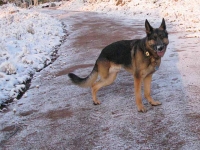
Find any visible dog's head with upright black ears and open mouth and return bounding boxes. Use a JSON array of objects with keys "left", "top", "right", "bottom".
[{"left": 145, "top": 18, "right": 169, "bottom": 57}]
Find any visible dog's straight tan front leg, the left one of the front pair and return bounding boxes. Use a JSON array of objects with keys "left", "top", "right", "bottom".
[{"left": 134, "top": 76, "right": 146, "bottom": 112}]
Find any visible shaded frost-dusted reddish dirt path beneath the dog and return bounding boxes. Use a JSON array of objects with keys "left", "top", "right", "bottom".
[{"left": 0, "top": 10, "right": 200, "bottom": 150}]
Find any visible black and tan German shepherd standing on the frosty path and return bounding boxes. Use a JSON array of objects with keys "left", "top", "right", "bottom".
[{"left": 68, "top": 18, "right": 169, "bottom": 112}]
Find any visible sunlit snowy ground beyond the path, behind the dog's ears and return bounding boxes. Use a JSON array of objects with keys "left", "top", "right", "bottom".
[{"left": 60, "top": 0, "right": 200, "bottom": 37}]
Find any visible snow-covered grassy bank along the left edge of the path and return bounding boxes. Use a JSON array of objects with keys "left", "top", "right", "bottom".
[{"left": 0, "top": 4, "right": 64, "bottom": 104}]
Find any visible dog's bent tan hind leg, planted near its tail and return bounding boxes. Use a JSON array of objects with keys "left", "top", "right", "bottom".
[{"left": 92, "top": 72, "right": 117, "bottom": 105}]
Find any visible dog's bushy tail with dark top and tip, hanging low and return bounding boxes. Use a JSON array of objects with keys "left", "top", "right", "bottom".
[{"left": 68, "top": 64, "right": 98, "bottom": 87}]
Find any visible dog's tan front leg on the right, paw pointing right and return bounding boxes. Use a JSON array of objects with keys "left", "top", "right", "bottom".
[{"left": 144, "top": 74, "right": 161, "bottom": 106}]
